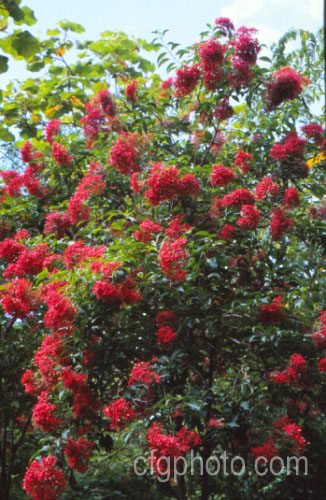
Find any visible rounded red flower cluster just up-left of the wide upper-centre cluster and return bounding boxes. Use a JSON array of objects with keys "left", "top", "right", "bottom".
[{"left": 109, "top": 132, "right": 141, "bottom": 175}]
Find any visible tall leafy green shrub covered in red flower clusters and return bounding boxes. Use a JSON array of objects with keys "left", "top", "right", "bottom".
[{"left": 0, "top": 6, "right": 326, "bottom": 500}]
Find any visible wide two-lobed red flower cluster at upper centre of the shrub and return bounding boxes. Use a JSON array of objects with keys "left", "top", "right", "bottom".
[{"left": 145, "top": 162, "right": 200, "bottom": 206}]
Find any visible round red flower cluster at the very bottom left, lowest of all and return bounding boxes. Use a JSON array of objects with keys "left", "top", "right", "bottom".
[{"left": 23, "top": 455, "right": 67, "bottom": 500}]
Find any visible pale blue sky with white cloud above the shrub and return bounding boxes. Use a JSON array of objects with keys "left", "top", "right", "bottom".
[{"left": 0, "top": 0, "right": 323, "bottom": 87}]
